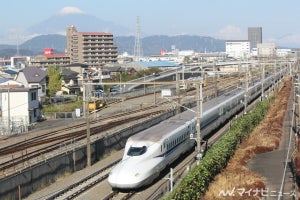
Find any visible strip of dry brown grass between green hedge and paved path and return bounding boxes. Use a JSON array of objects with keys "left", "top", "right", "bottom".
[{"left": 204, "top": 79, "right": 291, "bottom": 200}]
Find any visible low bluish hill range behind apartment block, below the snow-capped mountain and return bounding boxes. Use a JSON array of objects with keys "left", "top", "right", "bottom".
[{"left": 0, "top": 34, "right": 225, "bottom": 58}]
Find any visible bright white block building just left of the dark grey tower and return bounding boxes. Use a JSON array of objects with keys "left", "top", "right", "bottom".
[{"left": 226, "top": 40, "right": 250, "bottom": 59}]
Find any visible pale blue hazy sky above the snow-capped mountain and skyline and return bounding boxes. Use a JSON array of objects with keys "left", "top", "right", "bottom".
[{"left": 0, "top": 0, "right": 300, "bottom": 47}]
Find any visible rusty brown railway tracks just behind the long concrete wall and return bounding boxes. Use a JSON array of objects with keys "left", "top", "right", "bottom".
[{"left": 0, "top": 102, "right": 171, "bottom": 176}]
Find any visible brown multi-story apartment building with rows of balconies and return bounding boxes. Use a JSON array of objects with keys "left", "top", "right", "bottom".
[{"left": 66, "top": 26, "right": 118, "bottom": 66}]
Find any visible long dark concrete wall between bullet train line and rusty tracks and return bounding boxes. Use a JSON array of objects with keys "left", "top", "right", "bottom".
[{"left": 0, "top": 112, "right": 175, "bottom": 200}]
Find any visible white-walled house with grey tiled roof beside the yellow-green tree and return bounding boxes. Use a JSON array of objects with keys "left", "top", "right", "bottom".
[{"left": 15, "top": 67, "right": 47, "bottom": 100}]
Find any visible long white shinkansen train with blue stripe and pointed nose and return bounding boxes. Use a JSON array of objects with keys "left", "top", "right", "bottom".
[{"left": 108, "top": 70, "right": 281, "bottom": 189}]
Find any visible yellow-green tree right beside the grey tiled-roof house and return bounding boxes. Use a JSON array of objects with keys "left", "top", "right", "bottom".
[{"left": 47, "top": 66, "right": 62, "bottom": 102}]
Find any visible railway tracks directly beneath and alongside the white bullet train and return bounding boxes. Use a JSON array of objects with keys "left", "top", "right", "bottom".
[{"left": 55, "top": 115, "right": 230, "bottom": 200}]
